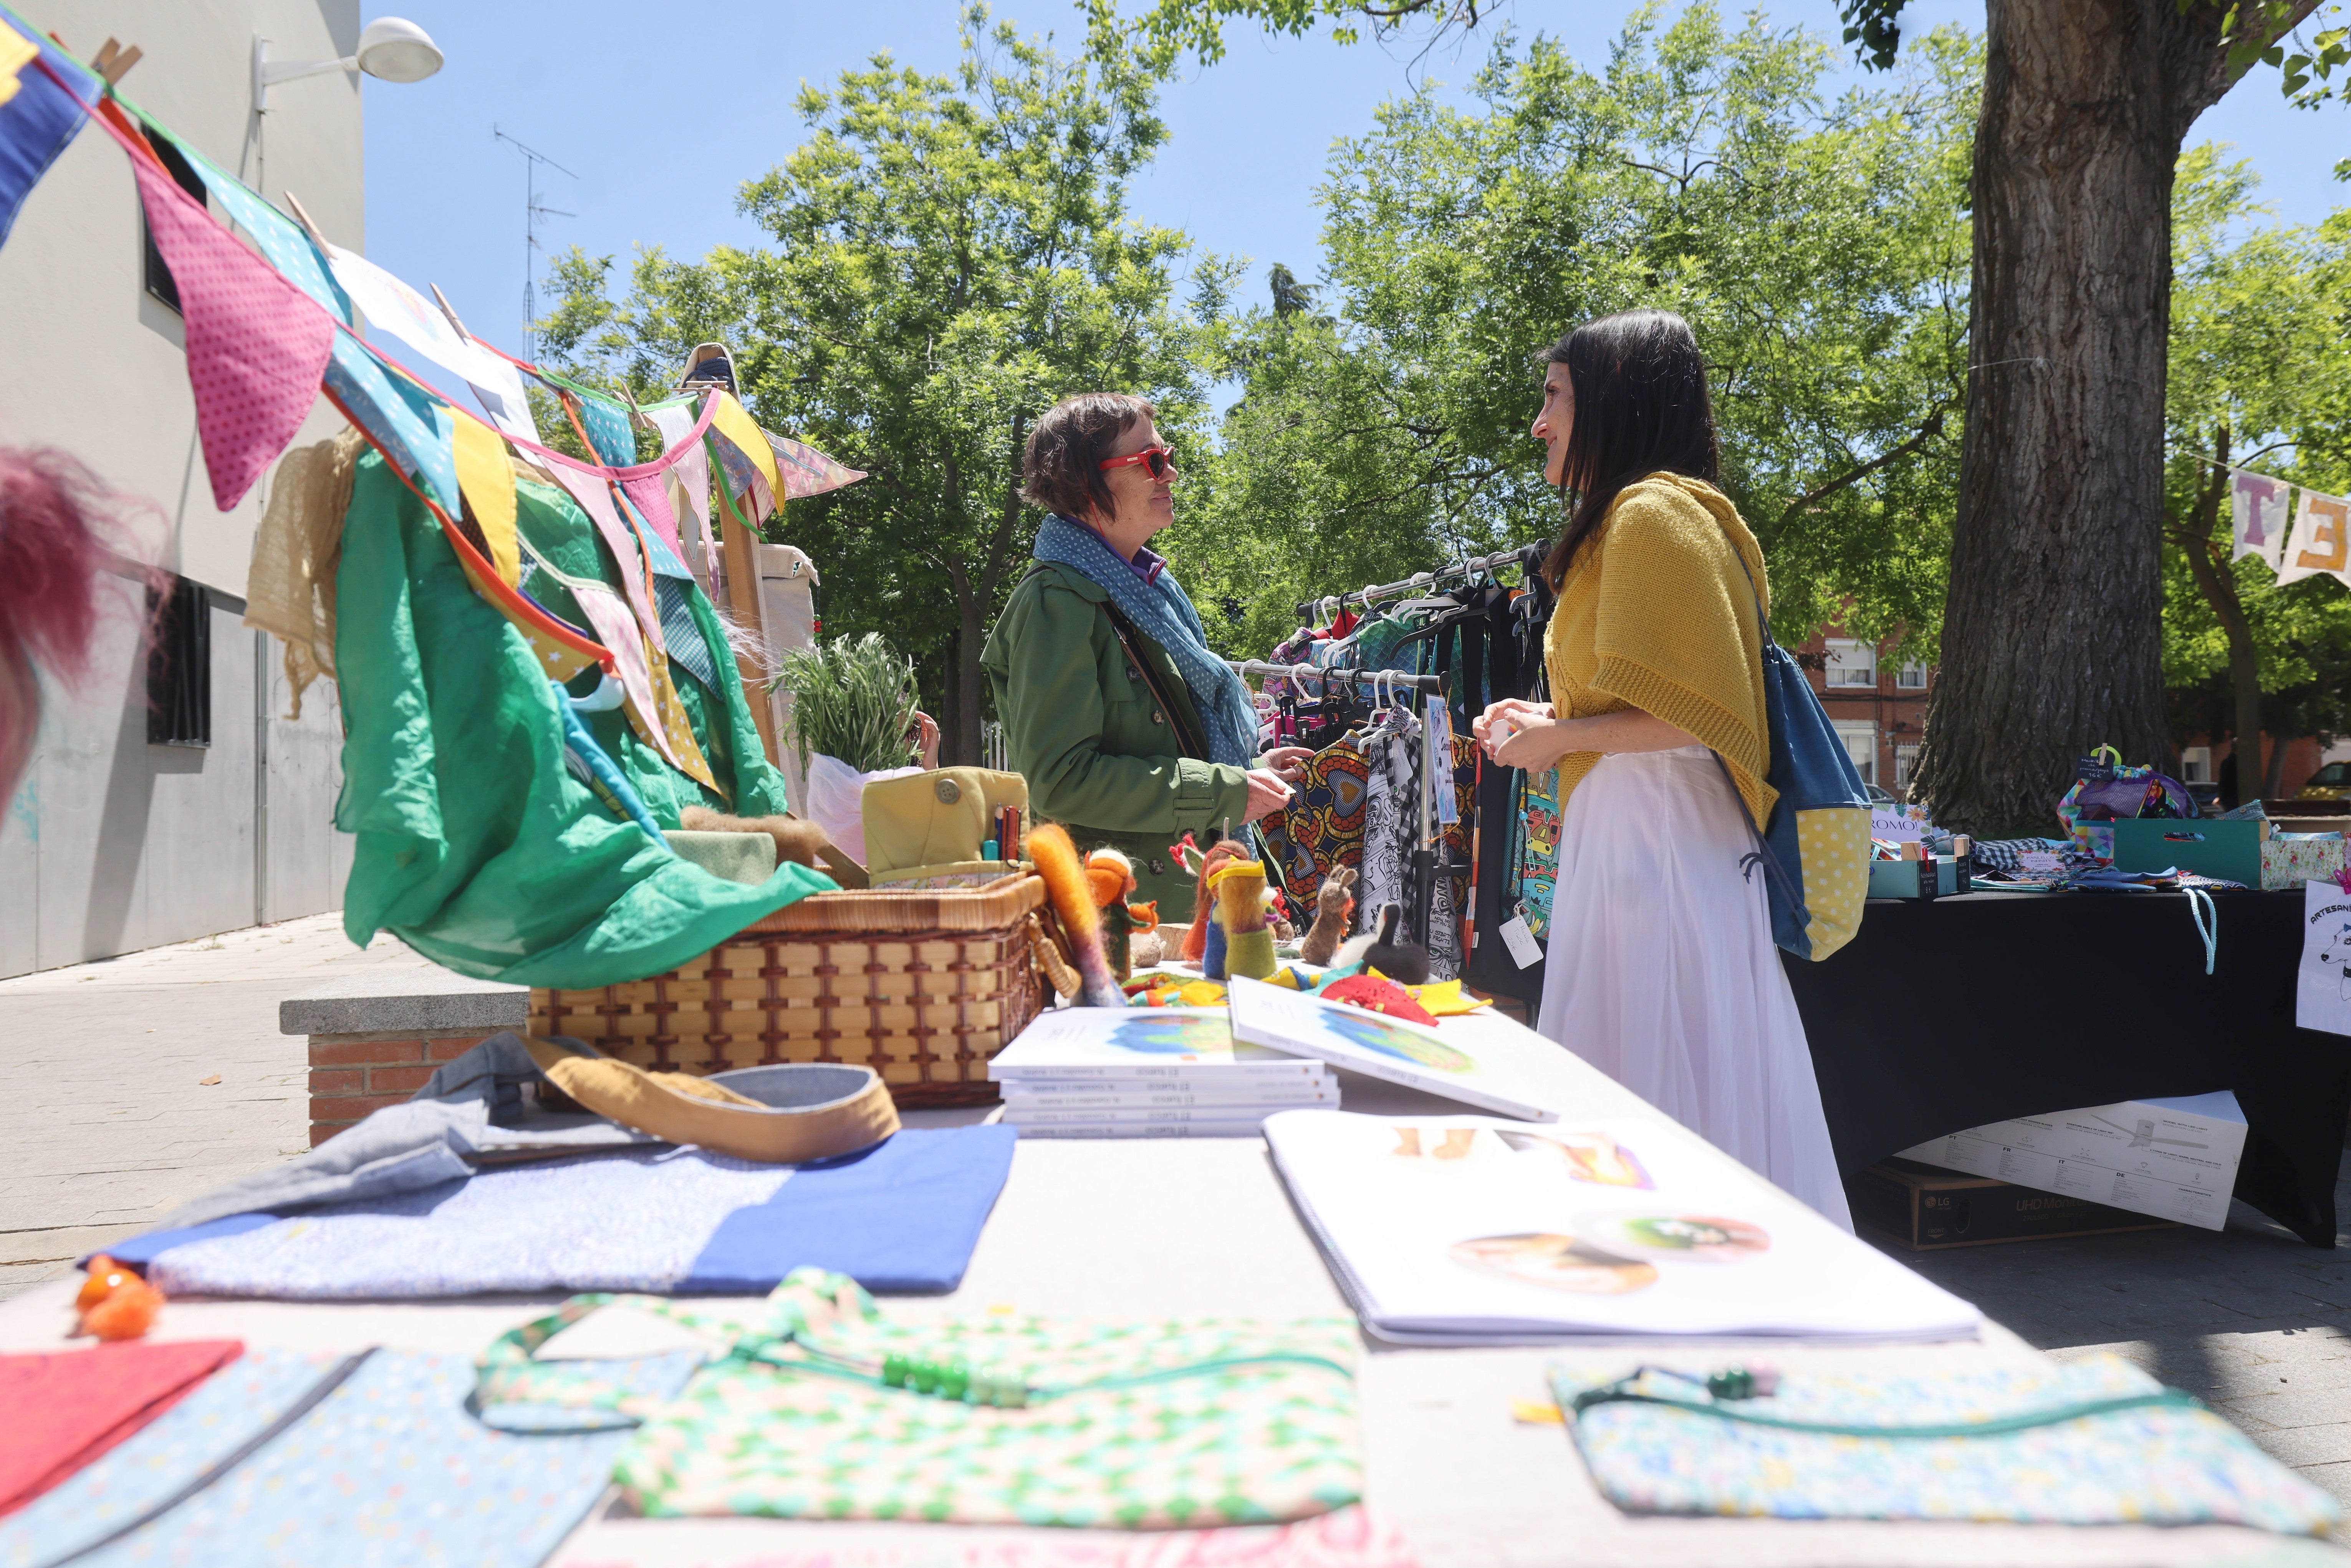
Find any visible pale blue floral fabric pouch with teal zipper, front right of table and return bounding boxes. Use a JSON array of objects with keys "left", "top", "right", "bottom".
[{"left": 1552, "top": 1354, "right": 2342, "bottom": 1535}]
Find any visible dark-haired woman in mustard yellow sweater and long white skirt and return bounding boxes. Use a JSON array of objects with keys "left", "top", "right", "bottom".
[{"left": 1474, "top": 310, "right": 1853, "bottom": 1230}]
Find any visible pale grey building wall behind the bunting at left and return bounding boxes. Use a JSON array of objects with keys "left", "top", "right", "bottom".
[{"left": 0, "top": 0, "right": 364, "bottom": 975}]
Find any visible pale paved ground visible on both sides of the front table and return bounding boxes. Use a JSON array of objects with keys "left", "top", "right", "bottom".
[{"left": 0, "top": 914, "right": 2351, "bottom": 1545}]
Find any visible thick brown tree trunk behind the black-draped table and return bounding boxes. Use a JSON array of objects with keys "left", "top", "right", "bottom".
[{"left": 1921, "top": 0, "right": 2227, "bottom": 837}]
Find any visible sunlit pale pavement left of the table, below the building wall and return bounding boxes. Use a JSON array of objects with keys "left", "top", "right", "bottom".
[{"left": 0, "top": 914, "right": 425, "bottom": 1300}]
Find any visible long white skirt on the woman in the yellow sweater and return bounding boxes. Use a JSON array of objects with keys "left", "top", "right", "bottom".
[{"left": 1538, "top": 745, "right": 1853, "bottom": 1230}]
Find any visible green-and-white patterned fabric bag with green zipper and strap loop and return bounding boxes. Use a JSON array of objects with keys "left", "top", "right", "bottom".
[{"left": 477, "top": 1270, "right": 1364, "bottom": 1528}]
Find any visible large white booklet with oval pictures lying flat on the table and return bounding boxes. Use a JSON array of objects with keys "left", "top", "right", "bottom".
[{"left": 1265, "top": 1109, "right": 1980, "bottom": 1344}]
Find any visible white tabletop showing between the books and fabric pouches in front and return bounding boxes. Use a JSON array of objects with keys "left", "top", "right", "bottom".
[{"left": 0, "top": 1015, "right": 2351, "bottom": 1568}]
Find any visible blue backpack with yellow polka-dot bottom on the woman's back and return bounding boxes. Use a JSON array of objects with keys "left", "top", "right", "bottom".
[{"left": 1714, "top": 529, "right": 1869, "bottom": 959}]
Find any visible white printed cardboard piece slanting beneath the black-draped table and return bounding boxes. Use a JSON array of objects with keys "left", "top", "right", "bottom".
[{"left": 1902, "top": 1091, "right": 2245, "bottom": 1230}]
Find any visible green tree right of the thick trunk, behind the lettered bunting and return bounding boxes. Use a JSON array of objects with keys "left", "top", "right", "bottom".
[{"left": 2163, "top": 155, "right": 2351, "bottom": 797}]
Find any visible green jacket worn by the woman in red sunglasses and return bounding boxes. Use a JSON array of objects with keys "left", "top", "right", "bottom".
[{"left": 980, "top": 562, "right": 1248, "bottom": 924}]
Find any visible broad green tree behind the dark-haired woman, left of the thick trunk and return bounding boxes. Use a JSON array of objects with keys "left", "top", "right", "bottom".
[{"left": 1178, "top": 5, "right": 1975, "bottom": 677}]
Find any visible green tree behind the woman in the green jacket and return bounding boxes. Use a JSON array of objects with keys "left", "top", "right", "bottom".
[{"left": 543, "top": 7, "right": 1230, "bottom": 762}]
